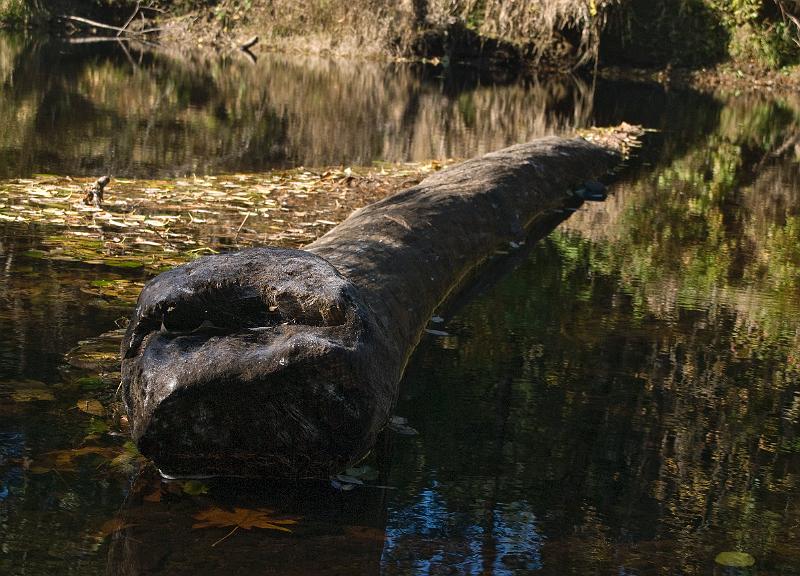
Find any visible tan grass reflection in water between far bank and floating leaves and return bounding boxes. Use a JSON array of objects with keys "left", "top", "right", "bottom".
[{"left": 0, "top": 35, "right": 592, "bottom": 178}]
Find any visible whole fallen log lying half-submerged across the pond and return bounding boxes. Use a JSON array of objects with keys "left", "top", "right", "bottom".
[{"left": 122, "top": 137, "right": 632, "bottom": 477}]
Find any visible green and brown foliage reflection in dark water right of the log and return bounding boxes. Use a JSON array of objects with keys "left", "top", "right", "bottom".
[{"left": 384, "top": 91, "right": 800, "bottom": 574}]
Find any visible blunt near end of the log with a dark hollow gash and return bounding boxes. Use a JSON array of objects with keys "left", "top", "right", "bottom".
[{"left": 122, "top": 248, "right": 397, "bottom": 477}]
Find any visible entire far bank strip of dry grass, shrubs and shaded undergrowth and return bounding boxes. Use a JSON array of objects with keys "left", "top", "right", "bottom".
[{"left": 0, "top": 0, "right": 800, "bottom": 90}]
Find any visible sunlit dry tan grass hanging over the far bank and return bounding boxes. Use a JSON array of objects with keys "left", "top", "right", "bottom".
[{"left": 158, "top": 0, "right": 622, "bottom": 63}]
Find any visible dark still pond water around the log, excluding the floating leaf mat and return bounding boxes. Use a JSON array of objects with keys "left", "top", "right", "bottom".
[{"left": 0, "top": 32, "right": 800, "bottom": 576}]
